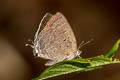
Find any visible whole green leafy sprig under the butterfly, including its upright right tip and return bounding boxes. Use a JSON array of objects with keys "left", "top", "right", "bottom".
[{"left": 32, "top": 39, "right": 120, "bottom": 80}]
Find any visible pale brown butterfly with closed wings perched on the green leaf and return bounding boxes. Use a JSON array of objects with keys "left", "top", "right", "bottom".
[{"left": 25, "top": 12, "right": 90, "bottom": 66}]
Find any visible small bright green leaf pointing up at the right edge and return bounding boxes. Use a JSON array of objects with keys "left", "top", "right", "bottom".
[{"left": 105, "top": 39, "right": 120, "bottom": 58}]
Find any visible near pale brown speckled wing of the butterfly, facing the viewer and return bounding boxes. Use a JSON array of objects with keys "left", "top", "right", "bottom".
[{"left": 33, "top": 12, "right": 77, "bottom": 62}]
